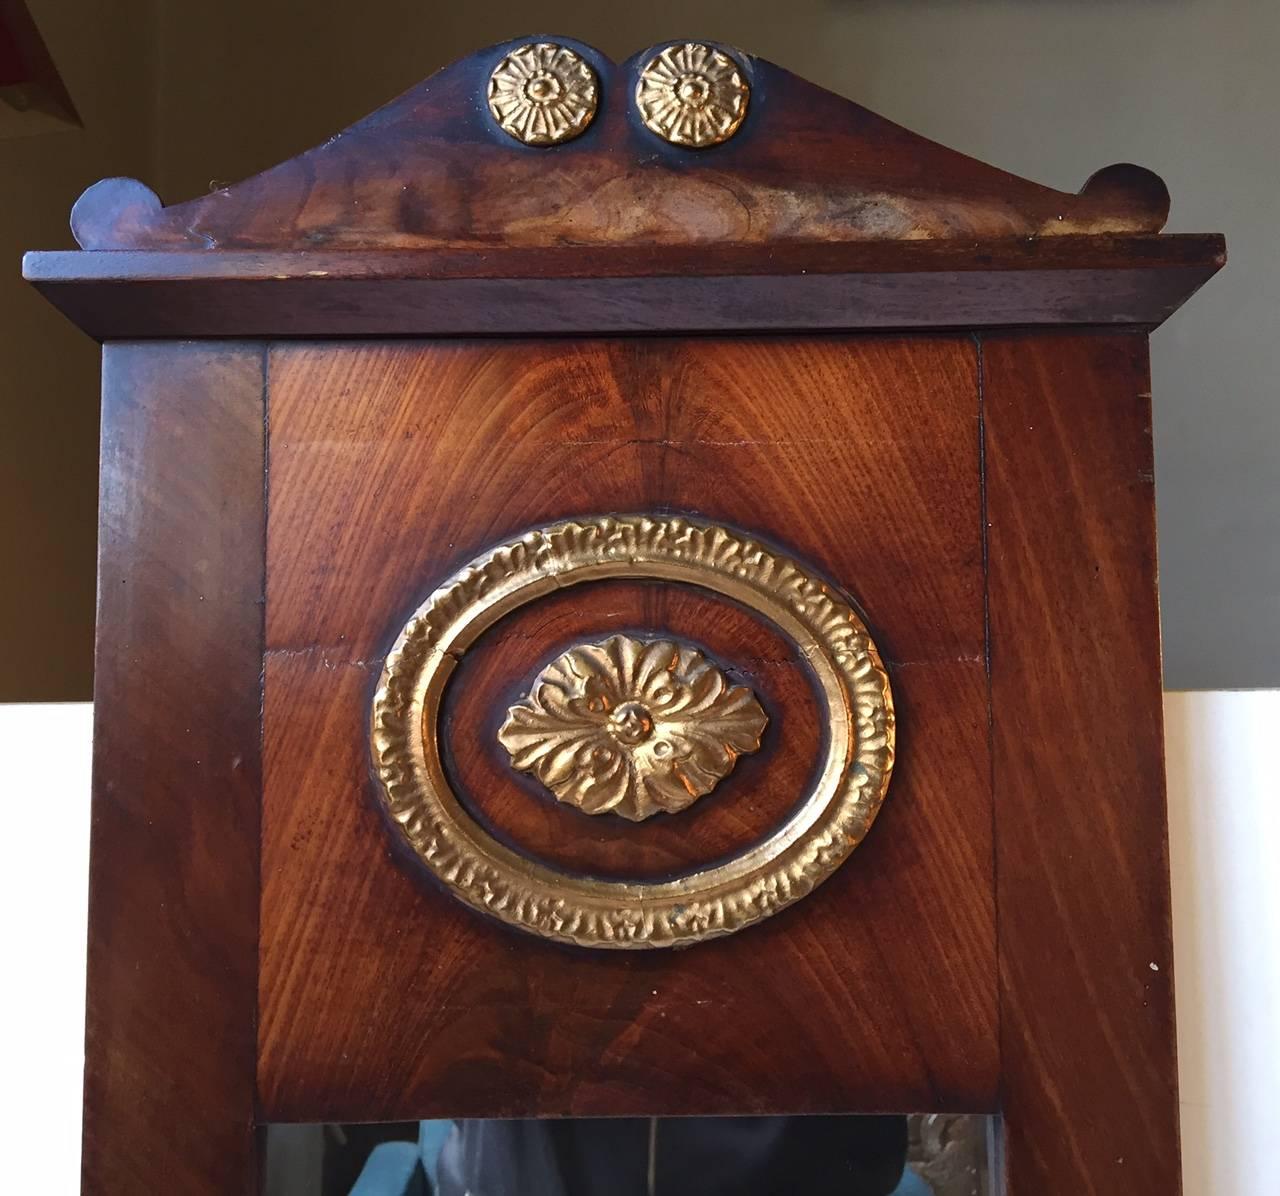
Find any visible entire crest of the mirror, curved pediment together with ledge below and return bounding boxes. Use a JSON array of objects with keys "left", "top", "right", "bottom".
[{"left": 26, "top": 37, "right": 1224, "bottom": 339}]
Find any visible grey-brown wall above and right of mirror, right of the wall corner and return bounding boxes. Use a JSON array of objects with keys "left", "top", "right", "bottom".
[{"left": 5, "top": 0, "right": 1280, "bottom": 688}]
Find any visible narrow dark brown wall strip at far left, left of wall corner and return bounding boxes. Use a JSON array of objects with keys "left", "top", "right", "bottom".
[{"left": 0, "top": 0, "right": 155, "bottom": 702}]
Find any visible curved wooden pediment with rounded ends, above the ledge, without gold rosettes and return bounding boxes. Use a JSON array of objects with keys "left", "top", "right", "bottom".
[{"left": 72, "top": 37, "right": 1169, "bottom": 251}]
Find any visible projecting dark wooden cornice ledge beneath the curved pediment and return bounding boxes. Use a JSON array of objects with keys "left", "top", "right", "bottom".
[{"left": 23, "top": 236, "right": 1225, "bottom": 339}]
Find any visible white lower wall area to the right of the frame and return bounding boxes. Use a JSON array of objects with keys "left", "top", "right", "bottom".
[{"left": 1165, "top": 690, "right": 1280, "bottom": 1196}]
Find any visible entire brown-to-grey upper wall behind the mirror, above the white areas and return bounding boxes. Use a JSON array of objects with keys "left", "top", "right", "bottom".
[{"left": 0, "top": 0, "right": 1280, "bottom": 699}]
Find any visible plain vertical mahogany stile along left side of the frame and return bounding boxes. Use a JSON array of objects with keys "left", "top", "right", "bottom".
[{"left": 83, "top": 343, "right": 265, "bottom": 1196}]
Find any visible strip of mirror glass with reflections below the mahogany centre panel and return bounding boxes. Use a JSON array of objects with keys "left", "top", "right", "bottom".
[{"left": 264, "top": 1113, "right": 992, "bottom": 1196}]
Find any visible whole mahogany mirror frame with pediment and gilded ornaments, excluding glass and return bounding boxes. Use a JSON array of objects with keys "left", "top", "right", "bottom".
[{"left": 26, "top": 37, "right": 1224, "bottom": 1196}]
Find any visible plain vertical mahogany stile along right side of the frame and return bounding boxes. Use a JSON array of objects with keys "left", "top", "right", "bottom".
[{"left": 982, "top": 333, "right": 1179, "bottom": 1196}]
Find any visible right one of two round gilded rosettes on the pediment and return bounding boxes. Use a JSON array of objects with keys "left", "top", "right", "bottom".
[{"left": 636, "top": 42, "right": 751, "bottom": 150}]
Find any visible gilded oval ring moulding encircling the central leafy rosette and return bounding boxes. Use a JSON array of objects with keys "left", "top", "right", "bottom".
[{"left": 371, "top": 515, "right": 893, "bottom": 949}]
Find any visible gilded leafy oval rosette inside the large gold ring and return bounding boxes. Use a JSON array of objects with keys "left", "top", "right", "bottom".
[{"left": 498, "top": 635, "right": 768, "bottom": 822}]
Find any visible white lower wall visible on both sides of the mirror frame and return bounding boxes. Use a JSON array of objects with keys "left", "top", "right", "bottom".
[{"left": 0, "top": 690, "right": 1280, "bottom": 1196}]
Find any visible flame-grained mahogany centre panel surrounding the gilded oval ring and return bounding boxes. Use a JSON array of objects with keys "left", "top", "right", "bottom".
[{"left": 259, "top": 337, "right": 997, "bottom": 1119}]
